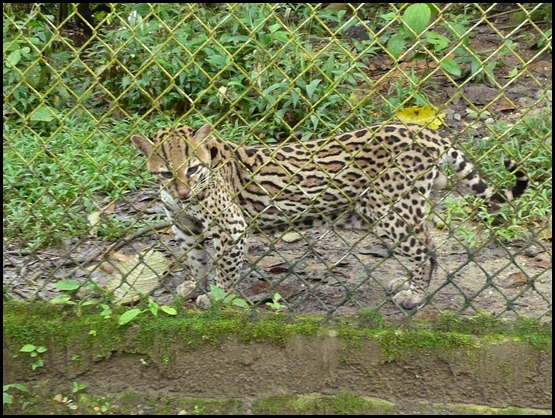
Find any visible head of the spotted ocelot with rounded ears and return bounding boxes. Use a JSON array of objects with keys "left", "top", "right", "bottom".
[{"left": 131, "top": 125, "right": 215, "bottom": 200}]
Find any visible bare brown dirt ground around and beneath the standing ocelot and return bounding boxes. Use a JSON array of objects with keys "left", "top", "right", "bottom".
[{"left": 4, "top": 185, "right": 552, "bottom": 319}]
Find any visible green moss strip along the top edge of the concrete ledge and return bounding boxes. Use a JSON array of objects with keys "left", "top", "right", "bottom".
[{"left": 3, "top": 302, "right": 551, "bottom": 361}]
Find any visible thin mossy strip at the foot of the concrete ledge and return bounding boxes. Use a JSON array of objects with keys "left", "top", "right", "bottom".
[{"left": 3, "top": 391, "right": 551, "bottom": 415}]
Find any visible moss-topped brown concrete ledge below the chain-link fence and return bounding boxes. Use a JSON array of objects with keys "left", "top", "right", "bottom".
[{"left": 4, "top": 303, "right": 552, "bottom": 414}]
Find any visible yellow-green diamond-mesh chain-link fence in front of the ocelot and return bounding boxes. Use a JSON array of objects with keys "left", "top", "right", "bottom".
[{"left": 3, "top": 3, "right": 552, "bottom": 320}]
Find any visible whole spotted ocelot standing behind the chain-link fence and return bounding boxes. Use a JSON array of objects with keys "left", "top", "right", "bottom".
[{"left": 131, "top": 124, "right": 528, "bottom": 309}]
